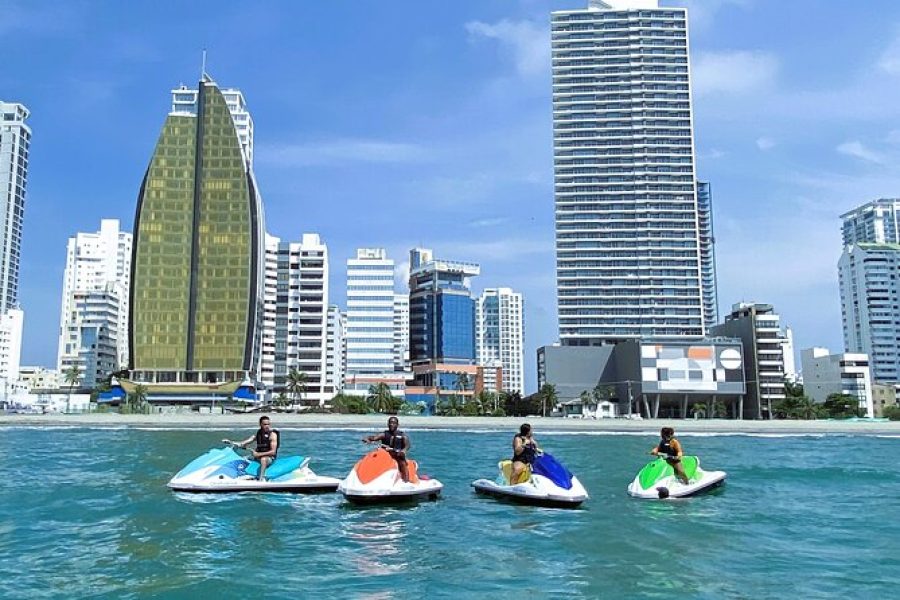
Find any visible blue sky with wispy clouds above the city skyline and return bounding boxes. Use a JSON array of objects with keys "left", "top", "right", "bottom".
[{"left": 0, "top": 0, "right": 900, "bottom": 390}]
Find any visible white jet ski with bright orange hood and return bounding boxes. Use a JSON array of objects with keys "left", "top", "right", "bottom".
[{"left": 338, "top": 447, "right": 444, "bottom": 504}]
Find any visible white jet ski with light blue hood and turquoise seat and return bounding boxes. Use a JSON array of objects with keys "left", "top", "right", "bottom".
[{"left": 167, "top": 447, "right": 340, "bottom": 494}]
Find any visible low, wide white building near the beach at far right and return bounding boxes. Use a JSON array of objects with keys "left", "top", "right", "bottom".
[{"left": 800, "top": 348, "right": 875, "bottom": 417}]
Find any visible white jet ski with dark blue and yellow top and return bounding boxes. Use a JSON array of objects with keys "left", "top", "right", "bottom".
[{"left": 472, "top": 452, "right": 588, "bottom": 508}]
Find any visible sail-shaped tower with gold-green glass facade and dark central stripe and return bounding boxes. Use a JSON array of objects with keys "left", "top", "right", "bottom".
[{"left": 129, "top": 77, "right": 263, "bottom": 383}]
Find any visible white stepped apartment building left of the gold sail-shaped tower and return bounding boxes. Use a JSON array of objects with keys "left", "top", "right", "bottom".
[{"left": 56, "top": 219, "right": 132, "bottom": 378}]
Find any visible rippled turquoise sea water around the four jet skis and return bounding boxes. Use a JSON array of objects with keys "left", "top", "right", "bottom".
[{"left": 0, "top": 428, "right": 900, "bottom": 599}]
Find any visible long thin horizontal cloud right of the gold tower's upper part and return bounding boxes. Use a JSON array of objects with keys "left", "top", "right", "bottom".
[{"left": 256, "top": 139, "right": 430, "bottom": 167}]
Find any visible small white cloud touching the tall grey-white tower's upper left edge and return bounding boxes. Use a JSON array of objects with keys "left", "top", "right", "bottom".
[{"left": 466, "top": 19, "right": 550, "bottom": 77}]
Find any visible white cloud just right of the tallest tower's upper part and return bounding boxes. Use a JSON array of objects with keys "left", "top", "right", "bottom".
[{"left": 693, "top": 51, "right": 778, "bottom": 96}]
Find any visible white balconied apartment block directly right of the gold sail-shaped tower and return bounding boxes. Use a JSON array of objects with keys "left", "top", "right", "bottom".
[{"left": 259, "top": 233, "right": 334, "bottom": 405}]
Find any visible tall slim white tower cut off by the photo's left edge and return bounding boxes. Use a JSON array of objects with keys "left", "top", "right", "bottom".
[{"left": 0, "top": 100, "right": 31, "bottom": 314}]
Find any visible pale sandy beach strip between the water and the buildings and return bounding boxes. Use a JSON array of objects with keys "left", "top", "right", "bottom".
[{"left": 0, "top": 412, "right": 900, "bottom": 437}]
